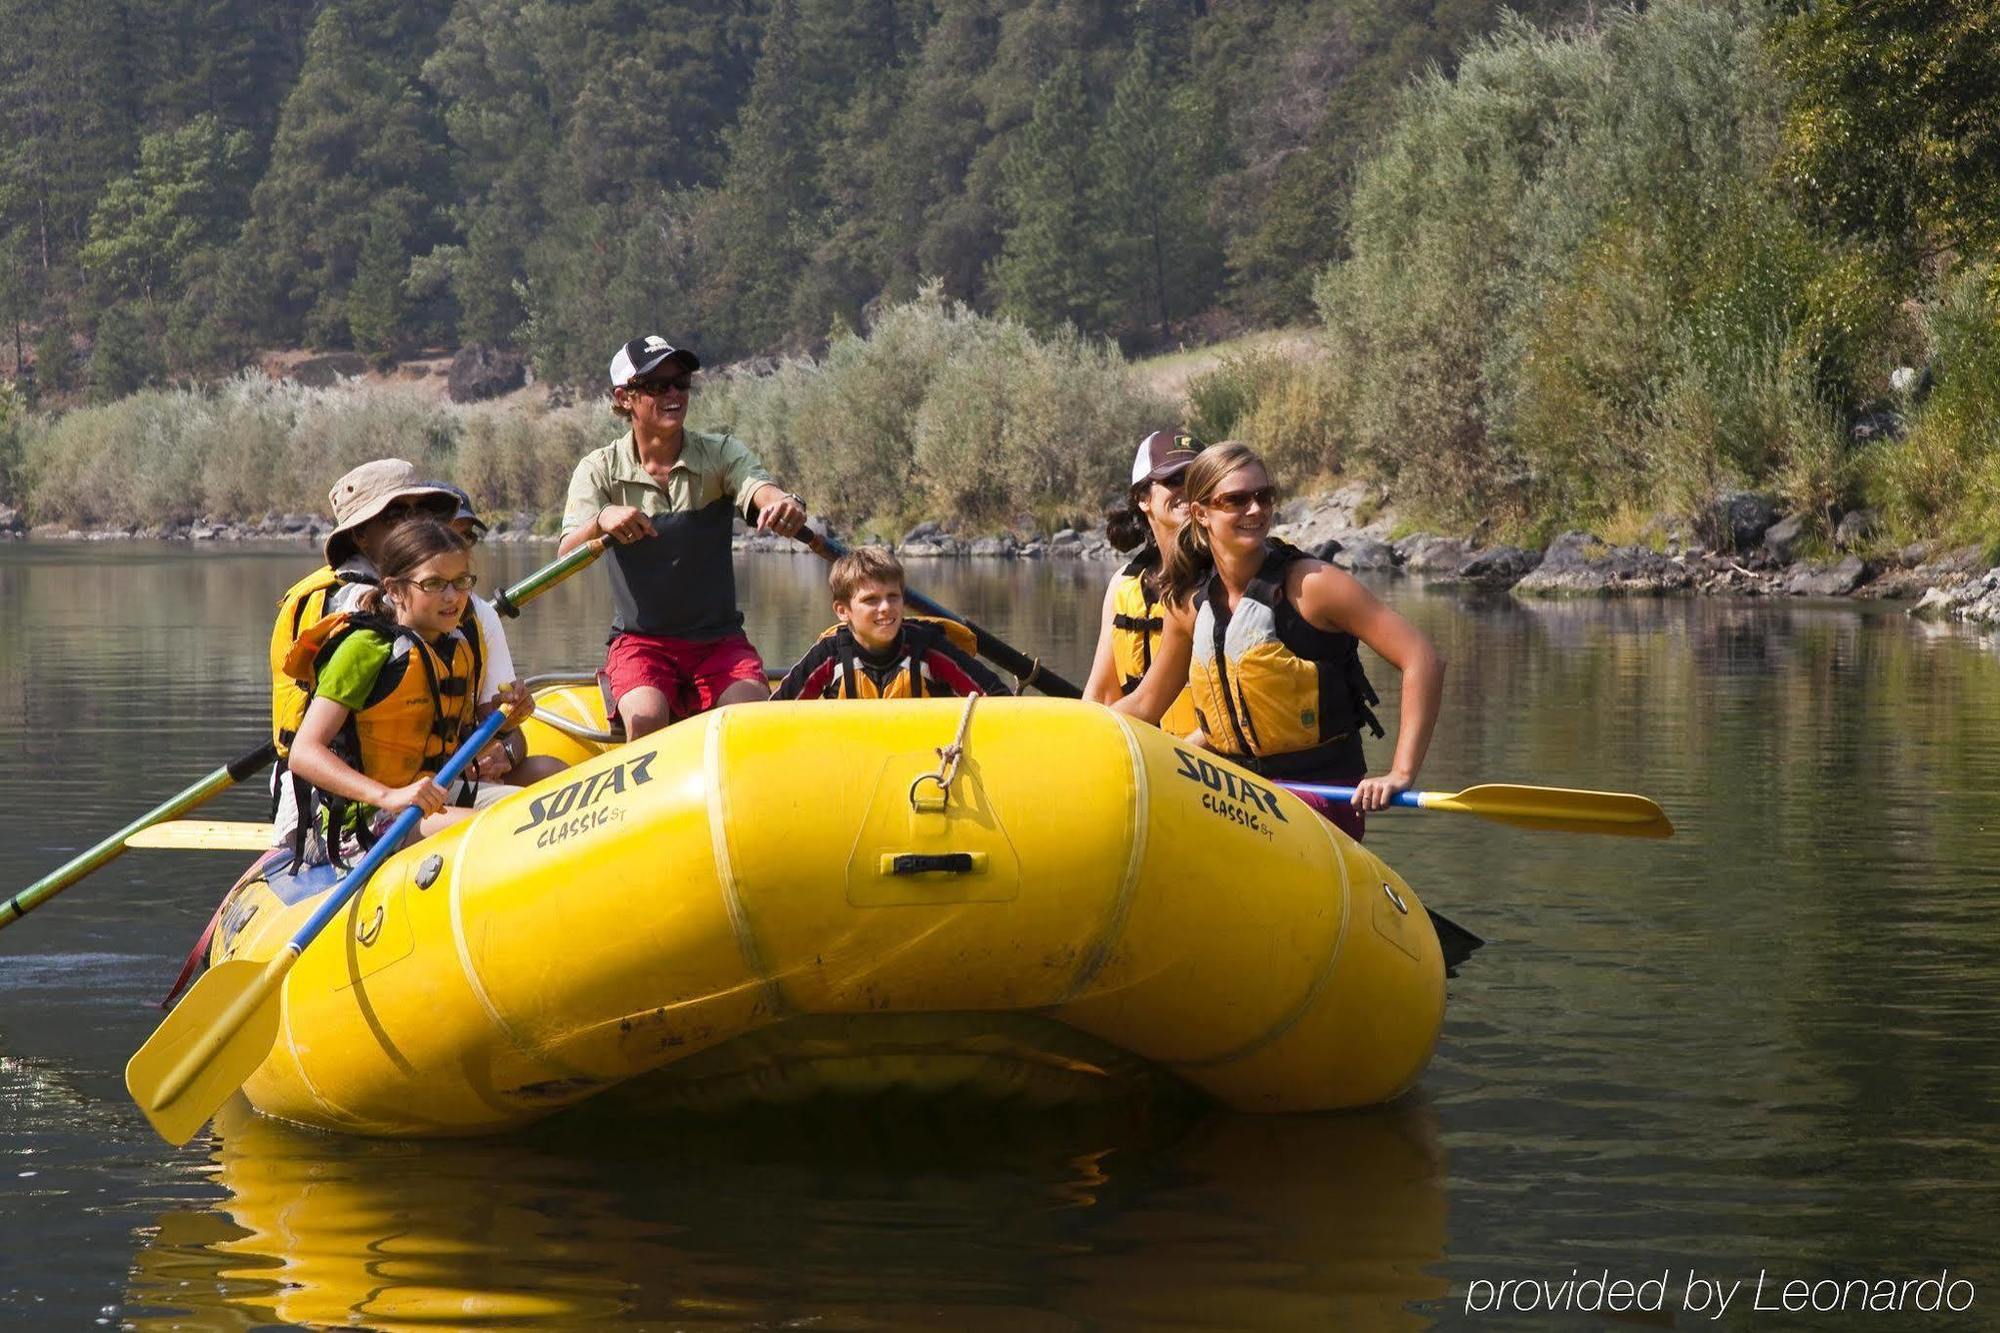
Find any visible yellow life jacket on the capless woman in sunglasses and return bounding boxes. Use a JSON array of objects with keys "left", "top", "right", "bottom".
[{"left": 1188, "top": 540, "right": 1382, "bottom": 761}]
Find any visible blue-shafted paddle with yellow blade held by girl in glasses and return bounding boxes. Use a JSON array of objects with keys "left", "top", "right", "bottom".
[{"left": 126, "top": 709, "right": 508, "bottom": 1145}]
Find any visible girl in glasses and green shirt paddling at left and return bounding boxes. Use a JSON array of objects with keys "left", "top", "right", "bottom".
[{"left": 286, "top": 518, "right": 532, "bottom": 865}]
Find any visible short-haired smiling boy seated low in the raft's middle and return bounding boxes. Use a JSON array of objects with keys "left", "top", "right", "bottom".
[{"left": 772, "top": 546, "right": 1008, "bottom": 699}]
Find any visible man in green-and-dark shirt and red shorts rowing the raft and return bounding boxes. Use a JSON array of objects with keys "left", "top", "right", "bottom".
[{"left": 556, "top": 334, "right": 806, "bottom": 739}]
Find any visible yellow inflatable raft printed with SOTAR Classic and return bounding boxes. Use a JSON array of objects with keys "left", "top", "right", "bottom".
[{"left": 212, "top": 699, "right": 1444, "bottom": 1135}]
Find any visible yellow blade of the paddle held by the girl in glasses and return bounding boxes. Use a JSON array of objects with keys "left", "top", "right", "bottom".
[{"left": 126, "top": 949, "right": 298, "bottom": 1145}]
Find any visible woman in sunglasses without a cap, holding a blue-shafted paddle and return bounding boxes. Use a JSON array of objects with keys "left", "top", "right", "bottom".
[{"left": 1112, "top": 442, "right": 1444, "bottom": 839}]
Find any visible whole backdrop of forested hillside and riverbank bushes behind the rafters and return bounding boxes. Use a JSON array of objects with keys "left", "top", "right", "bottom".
[{"left": 0, "top": 0, "right": 2000, "bottom": 558}]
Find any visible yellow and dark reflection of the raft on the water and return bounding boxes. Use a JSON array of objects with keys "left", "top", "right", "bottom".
[{"left": 126, "top": 1099, "right": 1446, "bottom": 1329}]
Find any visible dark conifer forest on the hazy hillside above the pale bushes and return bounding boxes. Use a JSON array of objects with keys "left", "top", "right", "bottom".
[{"left": 0, "top": 0, "right": 1582, "bottom": 400}]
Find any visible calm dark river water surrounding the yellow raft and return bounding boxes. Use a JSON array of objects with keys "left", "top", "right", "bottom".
[{"left": 0, "top": 544, "right": 2000, "bottom": 1329}]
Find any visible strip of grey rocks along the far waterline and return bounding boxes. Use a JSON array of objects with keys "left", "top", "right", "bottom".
[{"left": 0, "top": 482, "right": 2000, "bottom": 626}]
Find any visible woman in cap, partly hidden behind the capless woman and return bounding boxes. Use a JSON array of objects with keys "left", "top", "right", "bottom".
[{"left": 1084, "top": 430, "right": 1202, "bottom": 737}]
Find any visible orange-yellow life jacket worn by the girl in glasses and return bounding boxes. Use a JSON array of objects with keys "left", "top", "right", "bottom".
[{"left": 284, "top": 610, "right": 480, "bottom": 788}]
